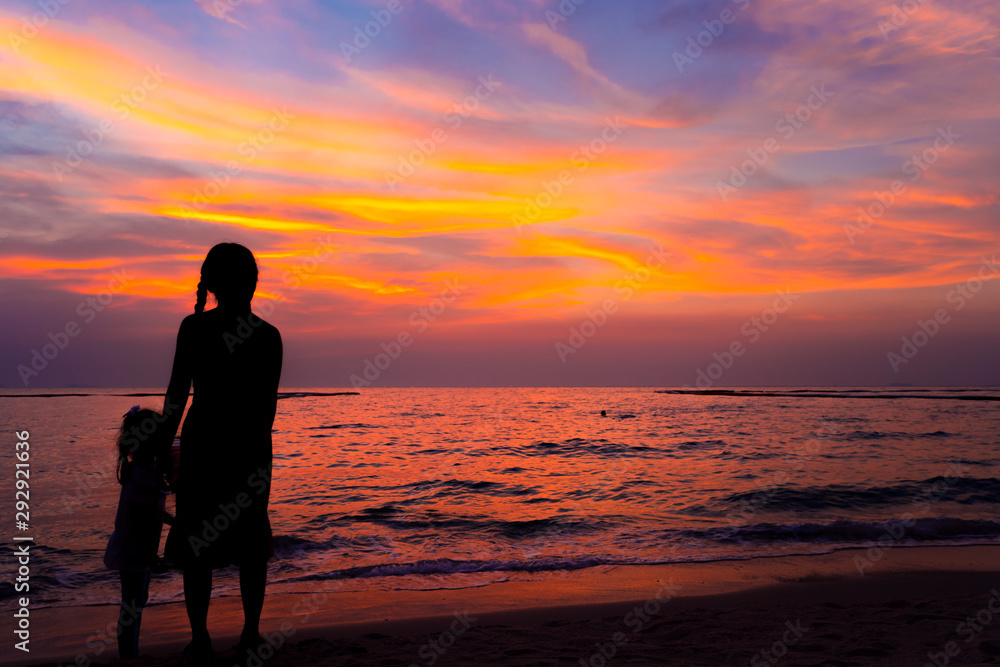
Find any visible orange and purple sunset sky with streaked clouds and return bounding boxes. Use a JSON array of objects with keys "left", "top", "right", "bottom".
[{"left": 0, "top": 0, "right": 1000, "bottom": 388}]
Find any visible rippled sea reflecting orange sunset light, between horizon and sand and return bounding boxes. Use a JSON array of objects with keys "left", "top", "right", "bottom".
[{"left": 0, "top": 387, "right": 1000, "bottom": 608}]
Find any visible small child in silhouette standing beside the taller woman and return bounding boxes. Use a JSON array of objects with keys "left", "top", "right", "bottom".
[{"left": 104, "top": 405, "right": 169, "bottom": 659}]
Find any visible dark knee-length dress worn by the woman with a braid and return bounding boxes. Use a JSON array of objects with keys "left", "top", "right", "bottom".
[{"left": 166, "top": 308, "right": 282, "bottom": 568}]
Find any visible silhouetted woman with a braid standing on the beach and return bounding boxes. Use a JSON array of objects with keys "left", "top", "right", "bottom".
[{"left": 164, "top": 243, "right": 282, "bottom": 664}]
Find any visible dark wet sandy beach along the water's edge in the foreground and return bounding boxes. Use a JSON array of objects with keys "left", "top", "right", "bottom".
[{"left": 4, "top": 546, "right": 1000, "bottom": 667}]
